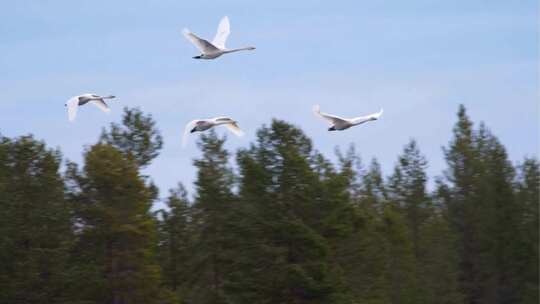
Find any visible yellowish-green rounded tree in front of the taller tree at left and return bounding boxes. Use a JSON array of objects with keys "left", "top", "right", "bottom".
[{"left": 66, "top": 144, "right": 160, "bottom": 303}]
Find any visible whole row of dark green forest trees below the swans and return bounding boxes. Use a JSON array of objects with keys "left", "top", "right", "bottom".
[{"left": 0, "top": 107, "right": 540, "bottom": 304}]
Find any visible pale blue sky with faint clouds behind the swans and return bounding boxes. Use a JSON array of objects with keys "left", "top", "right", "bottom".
[{"left": 0, "top": 0, "right": 540, "bottom": 202}]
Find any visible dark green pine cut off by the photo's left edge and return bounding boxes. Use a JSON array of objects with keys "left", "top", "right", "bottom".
[{"left": 0, "top": 136, "right": 73, "bottom": 303}]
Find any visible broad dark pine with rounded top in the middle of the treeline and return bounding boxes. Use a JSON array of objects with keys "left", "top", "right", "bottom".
[{"left": 232, "top": 120, "right": 349, "bottom": 303}]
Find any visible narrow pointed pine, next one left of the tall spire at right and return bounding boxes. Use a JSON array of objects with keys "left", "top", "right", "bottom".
[{"left": 388, "top": 140, "right": 461, "bottom": 303}]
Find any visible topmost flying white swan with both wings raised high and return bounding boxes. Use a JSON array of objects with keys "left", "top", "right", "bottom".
[{"left": 183, "top": 16, "right": 255, "bottom": 59}]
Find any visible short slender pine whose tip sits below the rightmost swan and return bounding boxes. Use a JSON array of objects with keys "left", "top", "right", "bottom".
[{"left": 350, "top": 158, "right": 417, "bottom": 303}]
